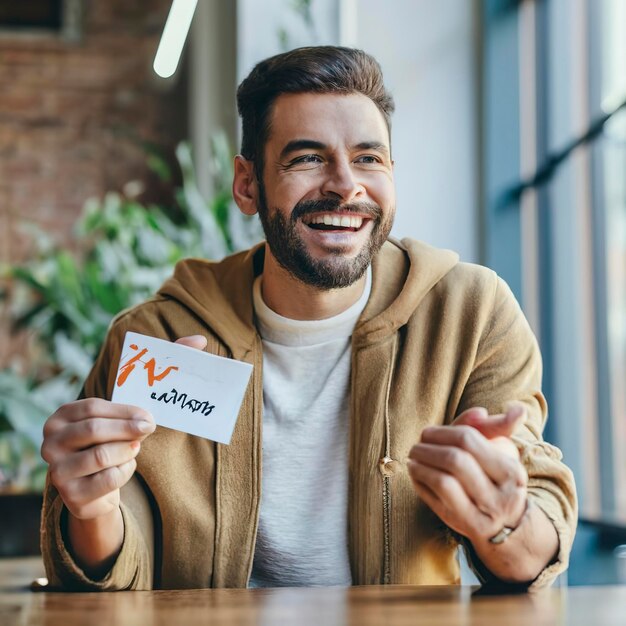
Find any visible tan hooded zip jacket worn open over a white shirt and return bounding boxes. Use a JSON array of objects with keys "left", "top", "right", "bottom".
[{"left": 42, "top": 240, "right": 576, "bottom": 590}]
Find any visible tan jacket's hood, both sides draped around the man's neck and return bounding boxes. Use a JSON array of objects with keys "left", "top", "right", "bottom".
[{"left": 158, "top": 239, "right": 458, "bottom": 360}]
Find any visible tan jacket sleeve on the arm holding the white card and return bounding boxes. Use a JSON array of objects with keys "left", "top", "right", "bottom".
[{"left": 41, "top": 314, "right": 153, "bottom": 591}]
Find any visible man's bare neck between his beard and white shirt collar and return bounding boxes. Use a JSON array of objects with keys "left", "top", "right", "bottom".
[{"left": 261, "top": 249, "right": 366, "bottom": 320}]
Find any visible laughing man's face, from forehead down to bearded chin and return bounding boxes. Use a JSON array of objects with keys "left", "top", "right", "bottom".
[{"left": 258, "top": 93, "right": 395, "bottom": 289}]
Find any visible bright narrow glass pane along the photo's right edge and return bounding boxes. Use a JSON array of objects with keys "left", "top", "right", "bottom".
[{"left": 594, "top": 0, "right": 626, "bottom": 520}]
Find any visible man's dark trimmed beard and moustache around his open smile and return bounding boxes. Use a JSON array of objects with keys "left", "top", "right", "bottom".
[{"left": 254, "top": 180, "right": 393, "bottom": 289}]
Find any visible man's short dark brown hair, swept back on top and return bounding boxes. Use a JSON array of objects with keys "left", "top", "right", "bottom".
[{"left": 237, "top": 46, "right": 395, "bottom": 180}]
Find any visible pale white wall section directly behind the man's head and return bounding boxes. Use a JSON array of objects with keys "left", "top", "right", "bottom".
[{"left": 237, "top": 0, "right": 479, "bottom": 261}]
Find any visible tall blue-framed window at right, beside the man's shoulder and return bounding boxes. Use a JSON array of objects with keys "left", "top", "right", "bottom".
[{"left": 484, "top": 0, "right": 626, "bottom": 528}]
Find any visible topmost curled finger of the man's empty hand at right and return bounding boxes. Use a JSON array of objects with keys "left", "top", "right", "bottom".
[{"left": 416, "top": 426, "right": 527, "bottom": 486}]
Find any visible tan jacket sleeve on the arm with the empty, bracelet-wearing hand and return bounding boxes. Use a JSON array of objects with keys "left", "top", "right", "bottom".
[{"left": 458, "top": 278, "right": 578, "bottom": 589}]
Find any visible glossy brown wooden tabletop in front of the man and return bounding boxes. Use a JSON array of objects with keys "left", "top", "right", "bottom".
[{"left": 0, "top": 558, "right": 626, "bottom": 626}]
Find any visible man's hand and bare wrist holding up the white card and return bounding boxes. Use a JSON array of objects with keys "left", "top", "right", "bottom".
[{"left": 41, "top": 335, "right": 207, "bottom": 579}]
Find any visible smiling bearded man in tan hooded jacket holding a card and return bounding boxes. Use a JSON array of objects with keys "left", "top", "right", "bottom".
[{"left": 42, "top": 47, "right": 576, "bottom": 589}]
